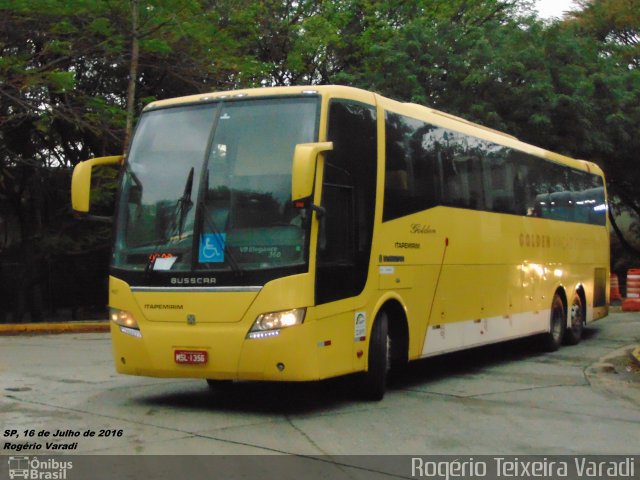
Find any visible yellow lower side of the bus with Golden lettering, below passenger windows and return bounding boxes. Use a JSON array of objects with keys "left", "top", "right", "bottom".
[{"left": 380, "top": 207, "right": 608, "bottom": 358}]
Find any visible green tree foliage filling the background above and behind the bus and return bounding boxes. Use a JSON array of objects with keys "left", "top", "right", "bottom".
[{"left": 0, "top": 0, "right": 640, "bottom": 266}]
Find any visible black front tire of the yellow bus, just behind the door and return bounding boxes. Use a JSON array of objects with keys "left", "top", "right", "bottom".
[{"left": 361, "top": 312, "right": 389, "bottom": 401}]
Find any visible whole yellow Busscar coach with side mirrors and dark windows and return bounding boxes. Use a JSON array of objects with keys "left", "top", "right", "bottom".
[{"left": 72, "top": 86, "right": 609, "bottom": 399}]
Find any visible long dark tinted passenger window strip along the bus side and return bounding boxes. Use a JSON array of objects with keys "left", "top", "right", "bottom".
[{"left": 382, "top": 112, "right": 607, "bottom": 225}]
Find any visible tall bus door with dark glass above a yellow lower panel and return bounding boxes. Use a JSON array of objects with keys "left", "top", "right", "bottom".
[{"left": 315, "top": 99, "right": 377, "bottom": 376}]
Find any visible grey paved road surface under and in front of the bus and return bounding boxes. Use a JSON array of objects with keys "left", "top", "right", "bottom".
[{"left": 0, "top": 313, "right": 640, "bottom": 462}]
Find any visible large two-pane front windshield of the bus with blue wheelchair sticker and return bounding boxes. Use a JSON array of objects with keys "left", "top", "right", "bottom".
[{"left": 113, "top": 97, "right": 318, "bottom": 271}]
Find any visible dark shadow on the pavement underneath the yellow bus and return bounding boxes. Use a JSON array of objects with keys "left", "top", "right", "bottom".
[{"left": 133, "top": 328, "right": 597, "bottom": 415}]
